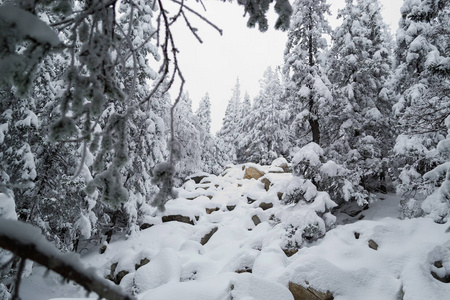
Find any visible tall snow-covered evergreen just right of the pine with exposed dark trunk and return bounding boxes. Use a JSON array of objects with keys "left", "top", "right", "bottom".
[{"left": 328, "top": 0, "right": 393, "bottom": 197}]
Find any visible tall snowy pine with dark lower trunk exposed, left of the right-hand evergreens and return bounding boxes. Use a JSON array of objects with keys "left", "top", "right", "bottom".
[{"left": 283, "top": 0, "right": 331, "bottom": 146}]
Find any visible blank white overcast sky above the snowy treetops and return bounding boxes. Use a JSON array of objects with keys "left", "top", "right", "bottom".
[{"left": 171, "top": 0, "right": 403, "bottom": 134}]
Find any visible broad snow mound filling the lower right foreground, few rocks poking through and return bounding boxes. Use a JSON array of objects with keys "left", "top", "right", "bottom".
[{"left": 280, "top": 219, "right": 450, "bottom": 300}]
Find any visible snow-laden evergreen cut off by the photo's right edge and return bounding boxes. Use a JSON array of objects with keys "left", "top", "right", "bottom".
[{"left": 393, "top": 0, "right": 450, "bottom": 218}]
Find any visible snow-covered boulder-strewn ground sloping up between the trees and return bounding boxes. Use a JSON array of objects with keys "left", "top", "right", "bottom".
[{"left": 21, "top": 164, "right": 450, "bottom": 300}]
